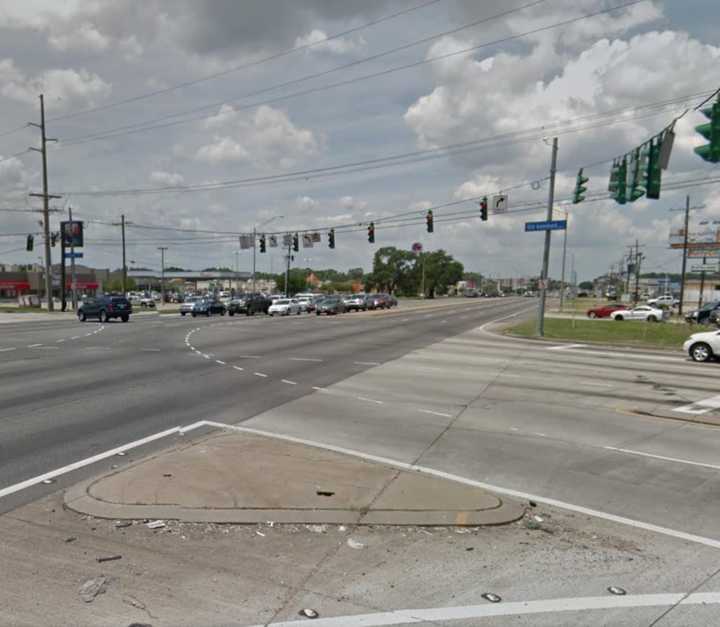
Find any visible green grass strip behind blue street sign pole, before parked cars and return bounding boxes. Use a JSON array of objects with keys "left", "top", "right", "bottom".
[{"left": 505, "top": 318, "right": 715, "bottom": 349}]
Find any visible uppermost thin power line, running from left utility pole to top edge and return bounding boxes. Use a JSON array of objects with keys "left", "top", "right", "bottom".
[{"left": 46, "top": 0, "right": 444, "bottom": 124}]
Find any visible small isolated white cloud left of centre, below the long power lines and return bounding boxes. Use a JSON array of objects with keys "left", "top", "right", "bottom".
[{"left": 195, "top": 105, "right": 322, "bottom": 169}]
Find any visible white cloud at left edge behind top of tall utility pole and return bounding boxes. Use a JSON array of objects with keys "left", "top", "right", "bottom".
[{"left": 0, "top": 59, "right": 111, "bottom": 110}]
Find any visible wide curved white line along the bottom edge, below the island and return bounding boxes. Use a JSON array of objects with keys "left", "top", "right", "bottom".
[{"left": 243, "top": 592, "right": 720, "bottom": 627}]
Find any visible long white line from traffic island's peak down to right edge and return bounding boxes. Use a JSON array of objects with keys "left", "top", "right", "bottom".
[{"left": 203, "top": 420, "right": 720, "bottom": 548}]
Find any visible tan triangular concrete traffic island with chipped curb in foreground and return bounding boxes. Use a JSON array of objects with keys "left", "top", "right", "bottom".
[{"left": 65, "top": 432, "right": 524, "bottom": 526}]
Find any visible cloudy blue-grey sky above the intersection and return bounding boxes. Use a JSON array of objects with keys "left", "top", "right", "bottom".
[{"left": 0, "top": 0, "right": 720, "bottom": 279}]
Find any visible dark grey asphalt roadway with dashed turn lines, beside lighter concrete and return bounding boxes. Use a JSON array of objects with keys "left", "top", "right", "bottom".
[{"left": 0, "top": 299, "right": 534, "bottom": 512}]
